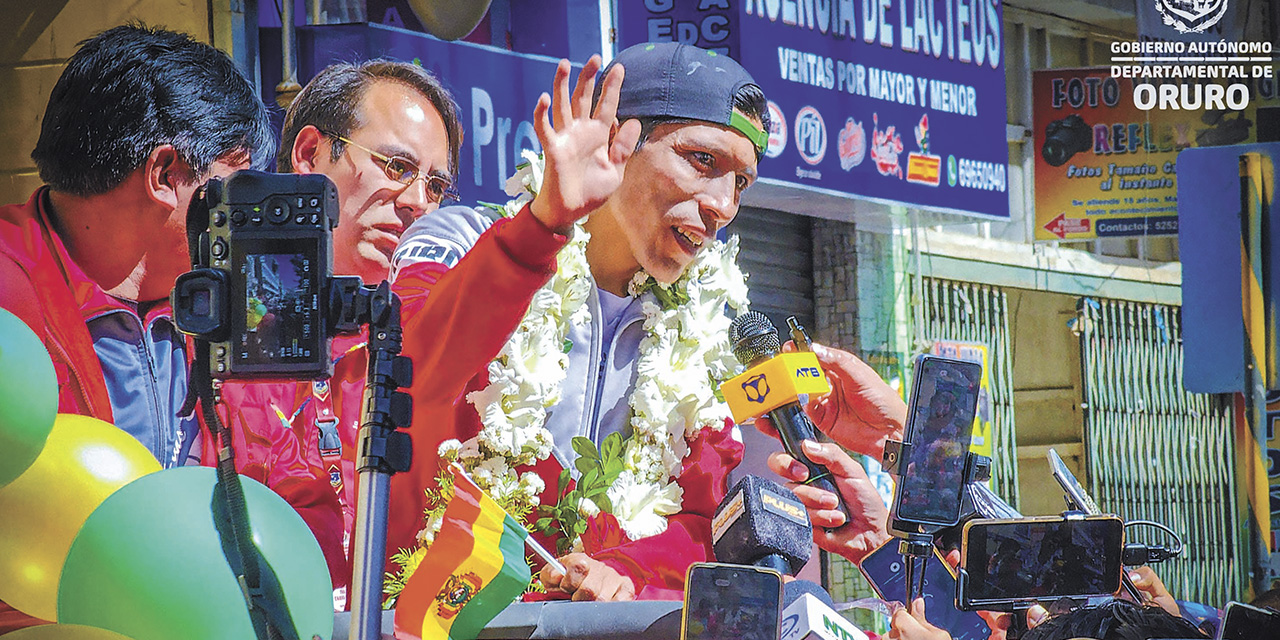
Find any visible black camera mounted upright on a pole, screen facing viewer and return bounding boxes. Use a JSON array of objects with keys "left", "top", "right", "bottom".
[{"left": 173, "top": 170, "right": 338, "bottom": 379}]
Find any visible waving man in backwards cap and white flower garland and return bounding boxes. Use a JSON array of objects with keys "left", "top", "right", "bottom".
[{"left": 388, "top": 44, "right": 768, "bottom": 600}]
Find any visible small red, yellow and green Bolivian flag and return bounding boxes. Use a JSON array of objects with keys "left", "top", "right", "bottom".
[{"left": 396, "top": 467, "right": 531, "bottom": 640}]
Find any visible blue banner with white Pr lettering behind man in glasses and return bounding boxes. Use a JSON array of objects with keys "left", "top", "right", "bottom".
[{"left": 262, "top": 24, "right": 558, "bottom": 205}]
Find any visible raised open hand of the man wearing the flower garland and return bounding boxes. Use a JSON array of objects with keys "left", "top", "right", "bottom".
[{"left": 530, "top": 55, "right": 640, "bottom": 232}]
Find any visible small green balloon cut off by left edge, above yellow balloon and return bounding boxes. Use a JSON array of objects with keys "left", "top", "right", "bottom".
[{"left": 0, "top": 308, "right": 58, "bottom": 486}]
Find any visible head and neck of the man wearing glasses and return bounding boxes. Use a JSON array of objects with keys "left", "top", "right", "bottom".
[{"left": 276, "top": 60, "right": 462, "bottom": 284}]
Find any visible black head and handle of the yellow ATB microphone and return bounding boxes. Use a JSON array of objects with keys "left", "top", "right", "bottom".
[{"left": 728, "top": 311, "right": 849, "bottom": 524}]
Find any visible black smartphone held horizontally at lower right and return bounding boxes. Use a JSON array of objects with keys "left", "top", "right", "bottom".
[{"left": 963, "top": 516, "right": 1124, "bottom": 605}]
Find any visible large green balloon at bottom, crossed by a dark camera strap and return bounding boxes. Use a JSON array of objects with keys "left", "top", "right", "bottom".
[{"left": 58, "top": 467, "right": 333, "bottom": 640}]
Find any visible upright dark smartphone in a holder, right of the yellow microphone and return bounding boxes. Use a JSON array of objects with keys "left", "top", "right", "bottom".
[{"left": 893, "top": 356, "right": 982, "bottom": 526}]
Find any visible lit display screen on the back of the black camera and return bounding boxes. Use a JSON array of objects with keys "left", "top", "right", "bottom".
[{"left": 232, "top": 238, "right": 323, "bottom": 371}]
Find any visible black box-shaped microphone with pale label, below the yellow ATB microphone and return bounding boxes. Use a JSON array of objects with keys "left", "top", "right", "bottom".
[{"left": 712, "top": 476, "right": 813, "bottom": 575}]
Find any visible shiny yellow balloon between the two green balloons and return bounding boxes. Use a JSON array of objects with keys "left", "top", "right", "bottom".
[{"left": 0, "top": 413, "right": 160, "bottom": 621}]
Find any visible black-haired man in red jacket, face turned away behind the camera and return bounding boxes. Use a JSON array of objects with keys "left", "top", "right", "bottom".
[{"left": 0, "top": 26, "right": 342, "bottom": 632}]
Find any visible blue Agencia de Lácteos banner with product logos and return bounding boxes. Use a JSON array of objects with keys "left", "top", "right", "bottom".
[{"left": 618, "top": 0, "right": 1009, "bottom": 219}]
